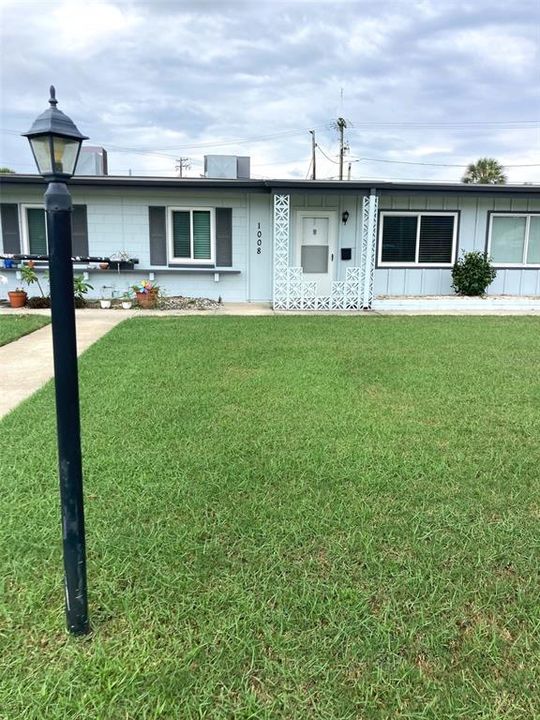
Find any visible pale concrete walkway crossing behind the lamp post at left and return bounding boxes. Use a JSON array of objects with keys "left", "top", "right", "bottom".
[{"left": 0, "top": 308, "right": 127, "bottom": 418}]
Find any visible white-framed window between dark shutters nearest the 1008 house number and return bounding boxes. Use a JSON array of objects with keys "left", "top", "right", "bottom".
[{"left": 169, "top": 208, "right": 215, "bottom": 264}]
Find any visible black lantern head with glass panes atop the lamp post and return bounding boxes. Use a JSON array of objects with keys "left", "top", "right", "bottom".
[{"left": 23, "top": 85, "right": 88, "bottom": 180}]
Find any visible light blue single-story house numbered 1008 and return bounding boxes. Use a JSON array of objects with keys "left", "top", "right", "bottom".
[{"left": 0, "top": 175, "right": 540, "bottom": 310}]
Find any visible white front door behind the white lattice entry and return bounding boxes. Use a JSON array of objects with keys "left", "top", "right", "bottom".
[{"left": 296, "top": 210, "right": 336, "bottom": 295}]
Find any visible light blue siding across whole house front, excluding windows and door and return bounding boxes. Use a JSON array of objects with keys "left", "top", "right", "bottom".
[{"left": 0, "top": 186, "right": 540, "bottom": 301}]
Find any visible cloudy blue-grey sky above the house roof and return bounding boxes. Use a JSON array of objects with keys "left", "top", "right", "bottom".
[{"left": 0, "top": 0, "right": 540, "bottom": 182}]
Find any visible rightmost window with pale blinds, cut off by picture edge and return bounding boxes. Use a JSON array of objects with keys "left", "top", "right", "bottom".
[{"left": 488, "top": 213, "right": 540, "bottom": 266}]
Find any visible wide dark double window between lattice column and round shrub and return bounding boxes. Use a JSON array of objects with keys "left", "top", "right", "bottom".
[{"left": 379, "top": 212, "right": 457, "bottom": 267}]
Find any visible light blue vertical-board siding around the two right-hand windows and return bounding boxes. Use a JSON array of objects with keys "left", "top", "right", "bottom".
[{"left": 374, "top": 194, "right": 540, "bottom": 297}]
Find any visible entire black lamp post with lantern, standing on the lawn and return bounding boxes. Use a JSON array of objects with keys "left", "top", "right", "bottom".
[{"left": 24, "top": 85, "right": 90, "bottom": 635}]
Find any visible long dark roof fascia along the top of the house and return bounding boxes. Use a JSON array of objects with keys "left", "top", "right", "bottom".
[{"left": 0, "top": 175, "right": 540, "bottom": 195}]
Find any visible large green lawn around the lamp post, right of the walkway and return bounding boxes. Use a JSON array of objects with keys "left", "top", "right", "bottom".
[{"left": 0, "top": 317, "right": 540, "bottom": 720}]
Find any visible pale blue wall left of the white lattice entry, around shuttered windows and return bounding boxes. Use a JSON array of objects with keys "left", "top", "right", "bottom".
[{"left": 0, "top": 186, "right": 262, "bottom": 301}]
